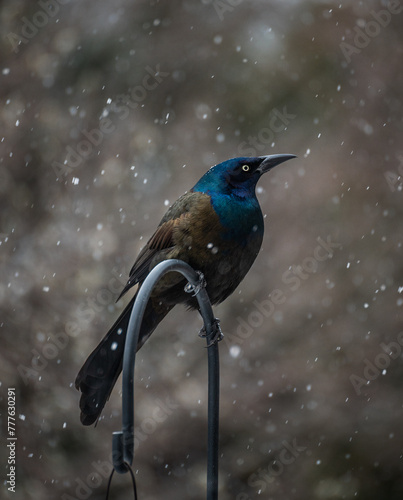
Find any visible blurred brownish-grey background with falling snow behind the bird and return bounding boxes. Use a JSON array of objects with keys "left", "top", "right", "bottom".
[{"left": 0, "top": 0, "right": 403, "bottom": 500}]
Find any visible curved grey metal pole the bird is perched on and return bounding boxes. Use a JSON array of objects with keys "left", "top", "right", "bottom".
[{"left": 112, "top": 259, "right": 220, "bottom": 500}]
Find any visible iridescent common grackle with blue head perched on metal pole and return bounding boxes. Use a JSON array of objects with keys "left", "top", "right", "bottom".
[{"left": 76, "top": 154, "right": 295, "bottom": 425}]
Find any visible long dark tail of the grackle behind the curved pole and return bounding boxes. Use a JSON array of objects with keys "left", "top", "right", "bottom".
[{"left": 75, "top": 295, "right": 173, "bottom": 425}]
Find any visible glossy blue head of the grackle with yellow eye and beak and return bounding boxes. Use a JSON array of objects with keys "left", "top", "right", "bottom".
[{"left": 192, "top": 154, "right": 296, "bottom": 197}]
